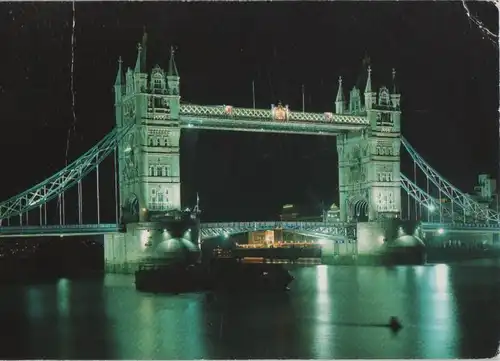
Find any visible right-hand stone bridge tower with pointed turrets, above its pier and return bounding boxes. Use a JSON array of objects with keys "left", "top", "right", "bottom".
[{"left": 335, "top": 67, "right": 401, "bottom": 221}]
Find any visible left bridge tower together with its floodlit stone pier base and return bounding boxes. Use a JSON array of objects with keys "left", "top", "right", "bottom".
[{"left": 104, "top": 33, "right": 194, "bottom": 273}]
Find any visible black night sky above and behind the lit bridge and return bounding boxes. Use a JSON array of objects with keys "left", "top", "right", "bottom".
[{"left": 0, "top": 2, "right": 499, "bottom": 220}]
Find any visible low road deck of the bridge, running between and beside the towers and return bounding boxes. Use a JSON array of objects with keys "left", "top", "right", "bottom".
[{"left": 0, "top": 221, "right": 500, "bottom": 239}]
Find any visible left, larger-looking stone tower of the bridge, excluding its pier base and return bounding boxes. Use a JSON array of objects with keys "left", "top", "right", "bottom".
[{"left": 115, "top": 34, "right": 181, "bottom": 224}]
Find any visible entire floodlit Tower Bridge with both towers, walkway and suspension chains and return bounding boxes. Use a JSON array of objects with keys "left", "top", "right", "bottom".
[{"left": 0, "top": 32, "right": 500, "bottom": 269}]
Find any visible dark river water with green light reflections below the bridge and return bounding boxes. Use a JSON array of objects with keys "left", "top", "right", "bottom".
[{"left": 0, "top": 260, "right": 500, "bottom": 359}]
